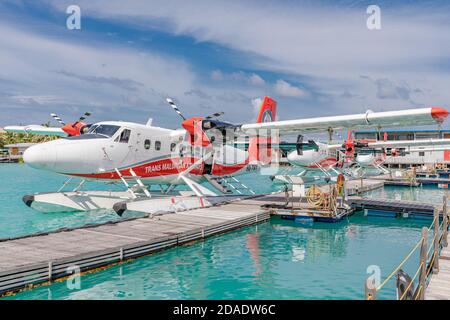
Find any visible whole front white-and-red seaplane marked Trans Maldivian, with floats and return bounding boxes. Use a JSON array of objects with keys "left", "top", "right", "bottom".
[{"left": 5, "top": 96, "right": 448, "bottom": 214}]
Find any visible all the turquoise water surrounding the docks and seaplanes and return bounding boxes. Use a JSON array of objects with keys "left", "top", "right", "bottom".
[{"left": 0, "top": 165, "right": 440, "bottom": 299}]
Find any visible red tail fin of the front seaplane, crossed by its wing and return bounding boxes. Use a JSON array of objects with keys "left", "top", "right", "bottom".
[{"left": 248, "top": 96, "right": 277, "bottom": 164}]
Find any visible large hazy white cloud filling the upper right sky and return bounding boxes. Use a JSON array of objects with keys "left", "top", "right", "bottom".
[{"left": 42, "top": 0, "right": 450, "bottom": 116}]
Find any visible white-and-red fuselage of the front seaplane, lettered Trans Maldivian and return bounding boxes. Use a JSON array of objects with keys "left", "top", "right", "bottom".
[{"left": 24, "top": 121, "right": 249, "bottom": 185}]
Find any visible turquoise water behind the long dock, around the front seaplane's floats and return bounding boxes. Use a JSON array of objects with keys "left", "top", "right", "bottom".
[{"left": 0, "top": 164, "right": 273, "bottom": 239}]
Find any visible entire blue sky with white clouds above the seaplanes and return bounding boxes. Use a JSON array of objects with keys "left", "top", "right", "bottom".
[{"left": 0, "top": 0, "right": 450, "bottom": 133}]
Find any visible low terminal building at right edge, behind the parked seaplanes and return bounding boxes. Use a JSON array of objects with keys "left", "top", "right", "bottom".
[{"left": 354, "top": 129, "right": 450, "bottom": 169}]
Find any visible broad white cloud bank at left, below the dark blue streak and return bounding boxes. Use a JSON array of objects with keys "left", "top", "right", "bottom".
[{"left": 0, "top": 23, "right": 196, "bottom": 125}]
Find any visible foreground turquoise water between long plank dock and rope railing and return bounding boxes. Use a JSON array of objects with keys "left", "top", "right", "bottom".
[{"left": 8, "top": 216, "right": 421, "bottom": 299}]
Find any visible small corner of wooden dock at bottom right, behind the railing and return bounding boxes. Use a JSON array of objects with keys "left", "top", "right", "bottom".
[{"left": 425, "top": 235, "right": 450, "bottom": 300}]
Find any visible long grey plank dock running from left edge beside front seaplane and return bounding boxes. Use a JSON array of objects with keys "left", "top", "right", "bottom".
[{"left": 0, "top": 197, "right": 270, "bottom": 295}]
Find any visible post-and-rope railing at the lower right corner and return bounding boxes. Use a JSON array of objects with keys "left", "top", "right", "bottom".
[{"left": 365, "top": 195, "right": 449, "bottom": 300}]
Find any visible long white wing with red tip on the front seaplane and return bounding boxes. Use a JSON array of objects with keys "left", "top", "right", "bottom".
[{"left": 240, "top": 107, "right": 449, "bottom": 135}]
